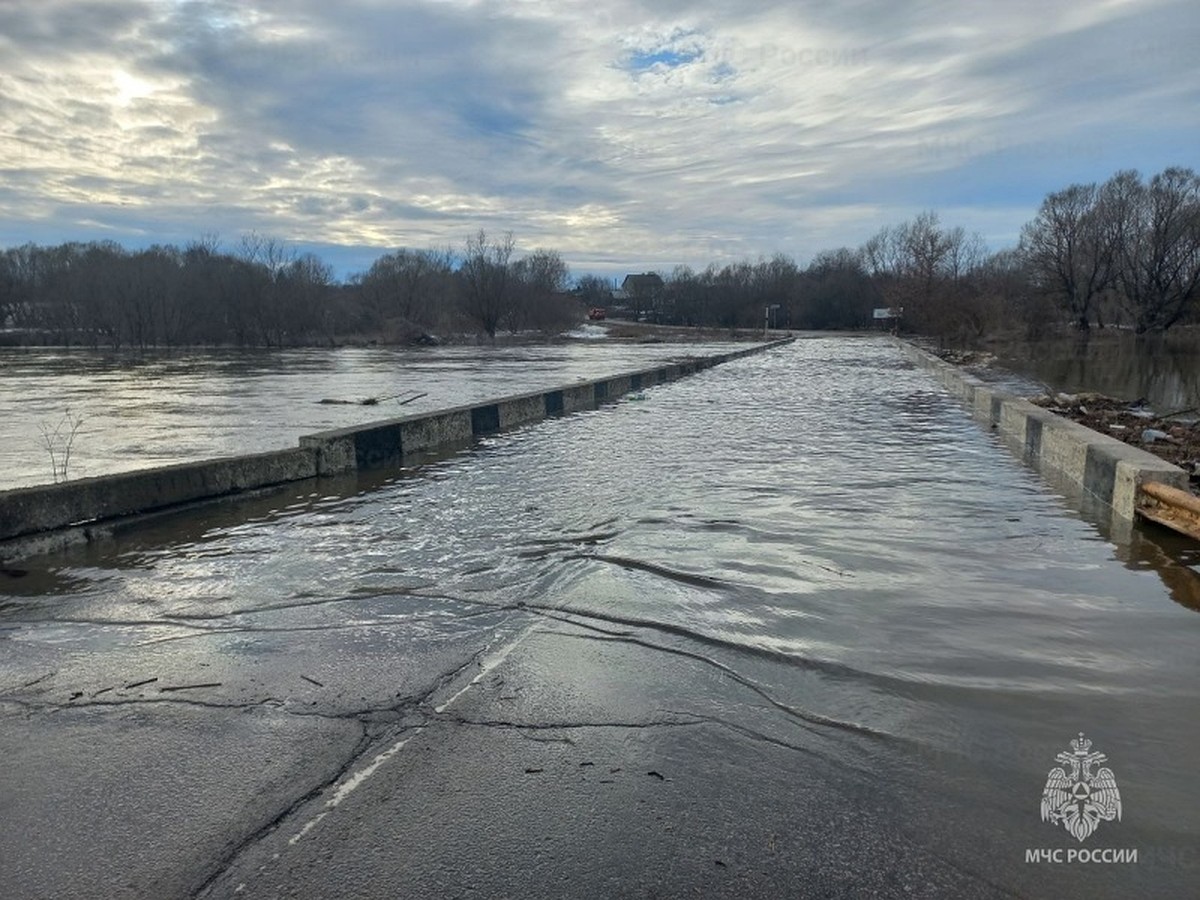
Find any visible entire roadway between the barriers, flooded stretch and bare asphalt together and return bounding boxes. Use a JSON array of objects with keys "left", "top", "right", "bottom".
[{"left": 0, "top": 337, "right": 1200, "bottom": 898}]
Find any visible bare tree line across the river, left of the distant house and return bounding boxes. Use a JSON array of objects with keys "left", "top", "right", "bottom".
[{"left": 0, "top": 232, "right": 583, "bottom": 350}]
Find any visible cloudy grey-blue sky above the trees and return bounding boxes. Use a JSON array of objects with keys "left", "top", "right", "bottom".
[{"left": 0, "top": 0, "right": 1200, "bottom": 275}]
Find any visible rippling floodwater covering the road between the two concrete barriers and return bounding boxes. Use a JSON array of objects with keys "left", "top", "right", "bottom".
[{"left": 0, "top": 337, "right": 1200, "bottom": 896}]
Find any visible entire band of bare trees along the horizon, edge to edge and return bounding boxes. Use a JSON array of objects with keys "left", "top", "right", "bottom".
[{"left": 0, "top": 167, "right": 1200, "bottom": 349}]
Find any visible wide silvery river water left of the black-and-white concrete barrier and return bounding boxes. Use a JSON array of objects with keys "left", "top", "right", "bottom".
[{"left": 0, "top": 340, "right": 736, "bottom": 490}]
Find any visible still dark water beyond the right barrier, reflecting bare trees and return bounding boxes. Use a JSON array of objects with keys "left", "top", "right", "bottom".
[{"left": 991, "top": 329, "right": 1200, "bottom": 413}]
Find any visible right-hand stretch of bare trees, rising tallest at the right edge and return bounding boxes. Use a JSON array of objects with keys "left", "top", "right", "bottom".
[{"left": 649, "top": 168, "right": 1200, "bottom": 341}]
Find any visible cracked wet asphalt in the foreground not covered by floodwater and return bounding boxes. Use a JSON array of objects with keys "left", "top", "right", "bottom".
[{"left": 0, "top": 614, "right": 1012, "bottom": 898}]
